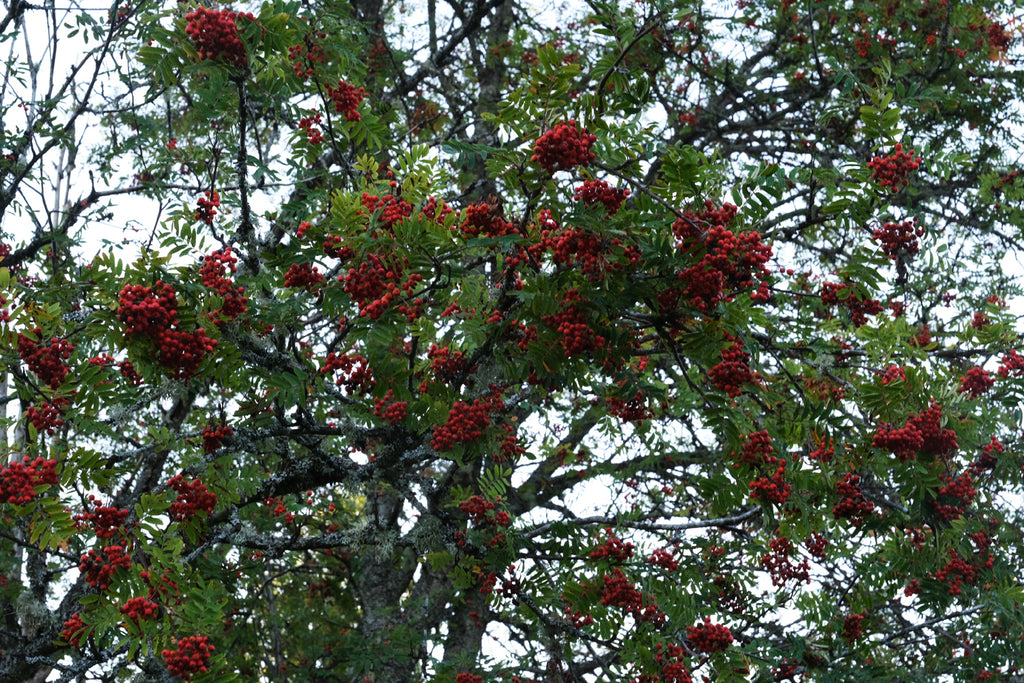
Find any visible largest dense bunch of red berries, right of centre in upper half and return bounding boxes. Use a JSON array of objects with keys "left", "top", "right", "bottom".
[{"left": 672, "top": 201, "right": 772, "bottom": 313}]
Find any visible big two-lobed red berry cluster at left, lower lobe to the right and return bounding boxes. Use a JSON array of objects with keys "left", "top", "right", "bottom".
[{"left": 118, "top": 281, "right": 217, "bottom": 378}]
